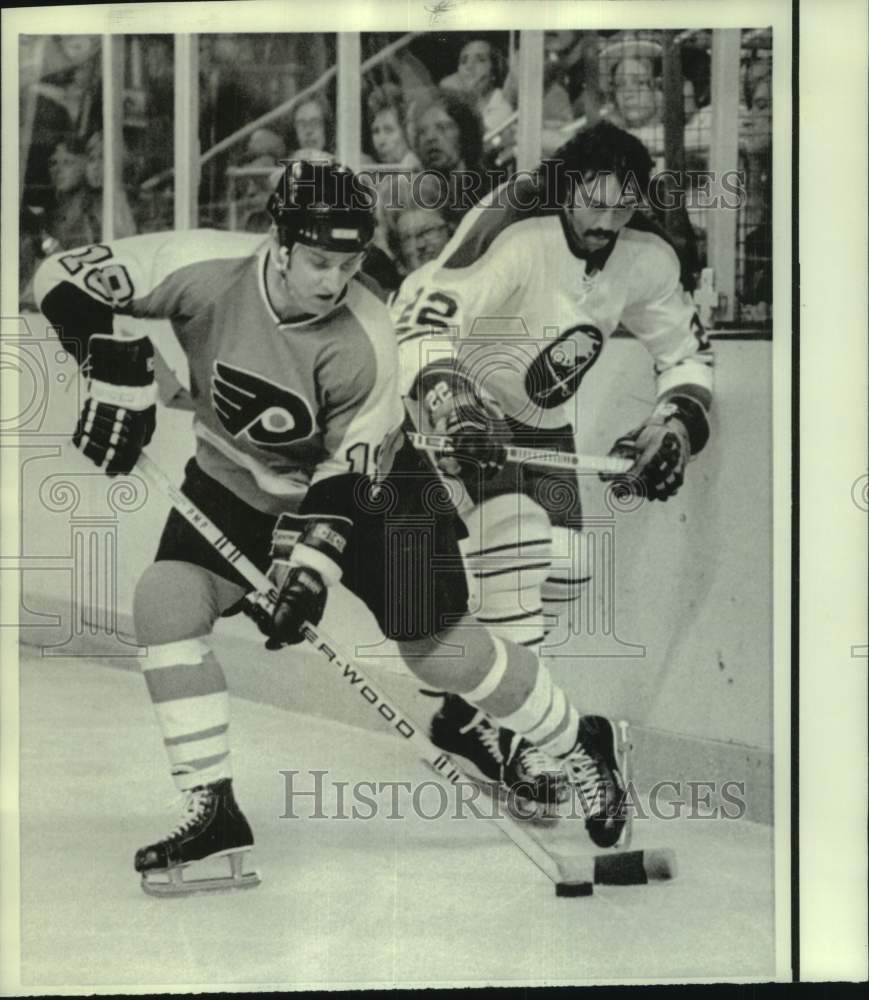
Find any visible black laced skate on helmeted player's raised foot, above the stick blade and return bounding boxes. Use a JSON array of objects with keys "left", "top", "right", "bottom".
[{"left": 562, "top": 715, "right": 631, "bottom": 847}]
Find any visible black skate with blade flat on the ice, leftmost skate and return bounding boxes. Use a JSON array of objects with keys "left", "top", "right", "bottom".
[{"left": 133, "top": 778, "right": 260, "bottom": 896}]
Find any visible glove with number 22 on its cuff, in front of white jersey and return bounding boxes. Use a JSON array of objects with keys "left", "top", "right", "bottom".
[{"left": 417, "top": 366, "right": 509, "bottom": 478}]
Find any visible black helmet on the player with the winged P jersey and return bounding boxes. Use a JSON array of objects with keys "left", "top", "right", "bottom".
[{"left": 267, "top": 160, "right": 376, "bottom": 253}]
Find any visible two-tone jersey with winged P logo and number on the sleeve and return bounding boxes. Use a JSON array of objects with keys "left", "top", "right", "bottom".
[{"left": 35, "top": 230, "right": 403, "bottom": 513}]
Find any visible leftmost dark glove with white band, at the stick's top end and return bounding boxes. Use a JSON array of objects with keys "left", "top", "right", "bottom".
[{"left": 72, "top": 333, "right": 157, "bottom": 476}]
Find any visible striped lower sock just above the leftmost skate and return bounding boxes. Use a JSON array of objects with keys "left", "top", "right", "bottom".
[{"left": 142, "top": 639, "right": 232, "bottom": 791}]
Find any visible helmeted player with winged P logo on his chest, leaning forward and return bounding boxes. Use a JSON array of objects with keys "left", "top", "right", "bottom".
[{"left": 35, "top": 162, "right": 632, "bottom": 894}]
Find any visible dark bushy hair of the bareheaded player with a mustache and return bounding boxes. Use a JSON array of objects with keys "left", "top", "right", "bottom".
[{"left": 540, "top": 120, "right": 653, "bottom": 205}]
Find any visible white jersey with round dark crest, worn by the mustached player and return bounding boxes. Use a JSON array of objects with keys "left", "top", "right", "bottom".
[{"left": 391, "top": 181, "right": 713, "bottom": 429}]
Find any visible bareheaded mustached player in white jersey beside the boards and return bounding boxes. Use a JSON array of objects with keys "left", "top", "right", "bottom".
[{"left": 392, "top": 121, "right": 713, "bottom": 804}]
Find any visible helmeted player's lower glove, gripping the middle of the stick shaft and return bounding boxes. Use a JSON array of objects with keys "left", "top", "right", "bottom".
[{"left": 252, "top": 514, "right": 352, "bottom": 650}]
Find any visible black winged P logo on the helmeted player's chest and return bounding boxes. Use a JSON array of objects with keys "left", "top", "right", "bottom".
[{"left": 211, "top": 361, "right": 314, "bottom": 448}]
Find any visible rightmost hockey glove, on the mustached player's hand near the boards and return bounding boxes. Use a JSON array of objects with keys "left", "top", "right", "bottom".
[{"left": 601, "top": 396, "right": 709, "bottom": 501}]
